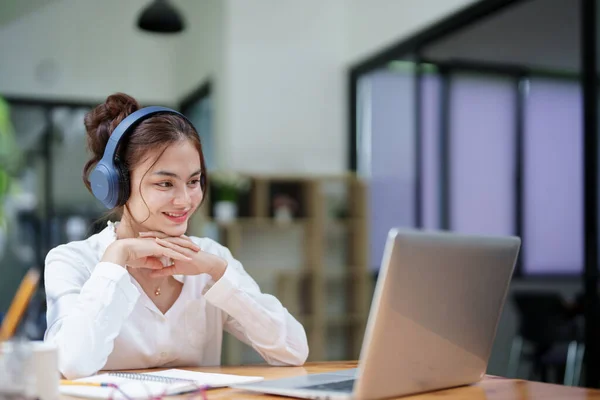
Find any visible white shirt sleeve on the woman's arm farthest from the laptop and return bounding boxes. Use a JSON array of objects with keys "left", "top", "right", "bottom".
[{"left": 44, "top": 245, "right": 140, "bottom": 379}]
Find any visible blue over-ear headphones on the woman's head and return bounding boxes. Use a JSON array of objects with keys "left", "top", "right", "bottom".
[{"left": 89, "top": 106, "right": 194, "bottom": 209}]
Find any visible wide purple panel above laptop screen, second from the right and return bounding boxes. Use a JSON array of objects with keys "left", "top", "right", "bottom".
[{"left": 449, "top": 75, "right": 515, "bottom": 235}]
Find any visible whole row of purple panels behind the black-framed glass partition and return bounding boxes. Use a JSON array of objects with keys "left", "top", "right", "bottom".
[{"left": 359, "top": 71, "right": 583, "bottom": 274}]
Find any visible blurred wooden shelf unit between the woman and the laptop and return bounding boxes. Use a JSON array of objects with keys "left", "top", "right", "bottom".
[{"left": 191, "top": 174, "right": 373, "bottom": 365}]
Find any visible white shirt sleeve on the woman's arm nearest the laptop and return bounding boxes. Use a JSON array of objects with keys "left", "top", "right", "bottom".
[{"left": 205, "top": 239, "right": 308, "bottom": 365}]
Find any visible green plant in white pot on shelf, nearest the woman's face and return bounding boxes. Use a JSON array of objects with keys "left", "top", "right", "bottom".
[{"left": 210, "top": 171, "right": 250, "bottom": 222}]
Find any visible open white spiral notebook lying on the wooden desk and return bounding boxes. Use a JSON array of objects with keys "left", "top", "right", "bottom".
[{"left": 60, "top": 369, "right": 264, "bottom": 399}]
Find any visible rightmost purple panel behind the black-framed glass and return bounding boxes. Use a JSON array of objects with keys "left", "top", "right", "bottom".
[{"left": 523, "top": 79, "right": 583, "bottom": 274}]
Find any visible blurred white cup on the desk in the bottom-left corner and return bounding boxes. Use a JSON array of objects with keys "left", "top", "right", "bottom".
[{"left": 0, "top": 341, "right": 60, "bottom": 400}]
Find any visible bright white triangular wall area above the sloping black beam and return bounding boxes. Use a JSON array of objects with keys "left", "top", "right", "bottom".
[{"left": 347, "top": 0, "right": 478, "bottom": 62}]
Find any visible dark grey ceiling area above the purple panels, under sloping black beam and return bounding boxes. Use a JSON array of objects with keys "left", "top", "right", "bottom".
[{"left": 423, "top": 0, "right": 580, "bottom": 72}]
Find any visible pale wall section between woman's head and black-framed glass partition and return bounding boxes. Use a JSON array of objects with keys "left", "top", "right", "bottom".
[{"left": 226, "top": 0, "right": 346, "bottom": 173}]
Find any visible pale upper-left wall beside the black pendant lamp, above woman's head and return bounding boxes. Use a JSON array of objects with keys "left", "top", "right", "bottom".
[{"left": 0, "top": 0, "right": 180, "bottom": 104}]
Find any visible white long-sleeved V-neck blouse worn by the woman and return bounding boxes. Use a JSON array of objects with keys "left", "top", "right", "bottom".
[{"left": 45, "top": 222, "right": 308, "bottom": 379}]
